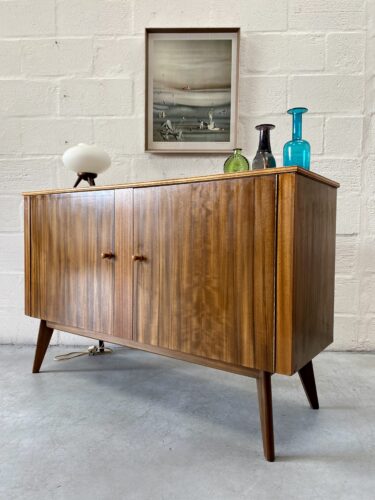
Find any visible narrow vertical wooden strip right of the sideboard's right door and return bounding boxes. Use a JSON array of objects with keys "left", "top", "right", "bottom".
[{"left": 275, "top": 174, "right": 296, "bottom": 374}]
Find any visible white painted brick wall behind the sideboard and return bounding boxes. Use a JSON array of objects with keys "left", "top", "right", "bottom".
[{"left": 0, "top": 0, "right": 375, "bottom": 350}]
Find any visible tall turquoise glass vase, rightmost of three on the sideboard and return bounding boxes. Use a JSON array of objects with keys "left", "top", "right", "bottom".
[{"left": 283, "top": 108, "right": 311, "bottom": 170}]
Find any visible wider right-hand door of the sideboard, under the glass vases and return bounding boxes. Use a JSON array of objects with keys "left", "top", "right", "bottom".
[{"left": 133, "top": 176, "right": 275, "bottom": 371}]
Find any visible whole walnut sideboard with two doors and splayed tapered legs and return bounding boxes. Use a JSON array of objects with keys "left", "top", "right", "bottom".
[{"left": 24, "top": 167, "right": 339, "bottom": 461}]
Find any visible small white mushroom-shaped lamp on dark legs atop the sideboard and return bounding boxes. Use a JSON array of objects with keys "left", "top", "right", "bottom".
[{"left": 62, "top": 143, "right": 111, "bottom": 187}]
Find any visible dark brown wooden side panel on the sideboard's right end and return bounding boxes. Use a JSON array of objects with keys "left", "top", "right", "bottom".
[{"left": 292, "top": 175, "right": 337, "bottom": 372}]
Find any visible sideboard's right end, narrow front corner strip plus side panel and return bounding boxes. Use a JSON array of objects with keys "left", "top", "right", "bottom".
[{"left": 276, "top": 174, "right": 336, "bottom": 375}]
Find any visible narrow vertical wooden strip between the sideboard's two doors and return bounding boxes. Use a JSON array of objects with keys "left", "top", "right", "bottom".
[{"left": 113, "top": 189, "right": 133, "bottom": 339}]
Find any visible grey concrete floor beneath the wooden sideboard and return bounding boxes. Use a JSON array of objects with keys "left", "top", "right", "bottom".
[{"left": 0, "top": 346, "right": 375, "bottom": 500}]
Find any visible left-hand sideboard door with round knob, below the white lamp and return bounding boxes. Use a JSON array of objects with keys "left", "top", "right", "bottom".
[{"left": 30, "top": 190, "right": 114, "bottom": 334}]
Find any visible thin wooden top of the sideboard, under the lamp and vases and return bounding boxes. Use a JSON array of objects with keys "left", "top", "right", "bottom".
[{"left": 22, "top": 167, "right": 340, "bottom": 196}]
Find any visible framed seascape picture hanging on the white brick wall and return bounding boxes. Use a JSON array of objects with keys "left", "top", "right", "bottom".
[{"left": 145, "top": 28, "right": 240, "bottom": 153}]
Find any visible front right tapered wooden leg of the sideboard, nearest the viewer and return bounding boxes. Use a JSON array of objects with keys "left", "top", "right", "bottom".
[{"left": 257, "top": 371, "right": 275, "bottom": 462}]
